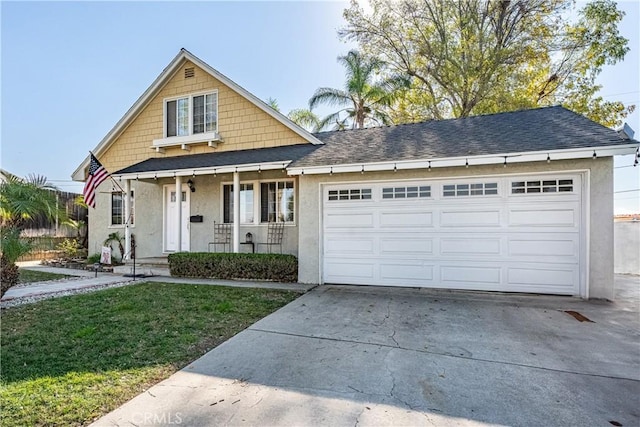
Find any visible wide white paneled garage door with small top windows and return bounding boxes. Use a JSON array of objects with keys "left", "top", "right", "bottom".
[{"left": 323, "top": 175, "right": 582, "bottom": 295}]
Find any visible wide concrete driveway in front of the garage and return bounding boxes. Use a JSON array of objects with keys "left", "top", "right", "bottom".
[{"left": 95, "top": 276, "right": 640, "bottom": 426}]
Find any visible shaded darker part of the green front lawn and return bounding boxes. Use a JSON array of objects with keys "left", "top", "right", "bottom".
[{"left": 1, "top": 283, "right": 299, "bottom": 384}]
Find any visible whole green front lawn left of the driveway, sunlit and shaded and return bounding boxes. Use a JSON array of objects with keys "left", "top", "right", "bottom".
[{"left": 0, "top": 283, "right": 299, "bottom": 427}]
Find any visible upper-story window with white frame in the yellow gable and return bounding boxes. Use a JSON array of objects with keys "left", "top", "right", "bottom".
[{"left": 165, "top": 92, "right": 218, "bottom": 137}]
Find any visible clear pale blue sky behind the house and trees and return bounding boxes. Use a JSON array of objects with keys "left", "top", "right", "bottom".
[{"left": 0, "top": 1, "right": 640, "bottom": 212}]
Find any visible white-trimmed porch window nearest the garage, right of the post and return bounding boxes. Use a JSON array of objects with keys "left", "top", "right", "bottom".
[{"left": 260, "top": 181, "right": 295, "bottom": 222}]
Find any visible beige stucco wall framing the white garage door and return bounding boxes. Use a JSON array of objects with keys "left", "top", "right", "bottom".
[{"left": 299, "top": 157, "right": 613, "bottom": 299}]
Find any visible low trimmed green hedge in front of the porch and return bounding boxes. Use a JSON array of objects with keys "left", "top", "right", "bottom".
[{"left": 169, "top": 252, "right": 298, "bottom": 282}]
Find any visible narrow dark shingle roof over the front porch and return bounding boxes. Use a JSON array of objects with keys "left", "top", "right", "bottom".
[{"left": 113, "top": 144, "right": 318, "bottom": 175}]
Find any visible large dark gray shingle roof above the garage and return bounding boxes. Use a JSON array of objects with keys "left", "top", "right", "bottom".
[{"left": 291, "top": 106, "right": 637, "bottom": 167}]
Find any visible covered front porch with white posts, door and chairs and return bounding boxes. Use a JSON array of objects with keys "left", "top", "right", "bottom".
[{"left": 96, "top": 145, "right": 309, "bottom": 262}]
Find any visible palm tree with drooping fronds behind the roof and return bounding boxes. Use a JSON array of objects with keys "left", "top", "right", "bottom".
[{"left": 309, "top": 50, "right": 409, "bottom": 130}]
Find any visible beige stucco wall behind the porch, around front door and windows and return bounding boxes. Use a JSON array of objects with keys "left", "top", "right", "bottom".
[{"left": 89, "top": 171, "right": 300, "bottom": 258}]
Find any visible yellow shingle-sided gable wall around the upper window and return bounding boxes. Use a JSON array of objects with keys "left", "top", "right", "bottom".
[{"left": 98, "top": 62, "right": 305, "bottom": 172}]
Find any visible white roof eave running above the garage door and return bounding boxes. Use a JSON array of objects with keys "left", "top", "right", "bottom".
[{"left": 287, "top": 143, "right": 638, "bottom": 175}]
